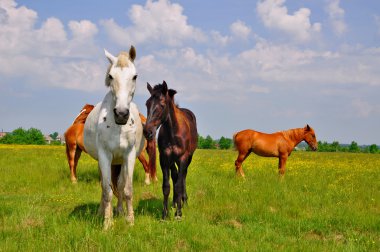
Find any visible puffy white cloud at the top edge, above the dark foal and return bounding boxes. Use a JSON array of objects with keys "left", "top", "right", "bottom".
[{"left": 101, "top": 0, "right": 206, "bottom": 46}]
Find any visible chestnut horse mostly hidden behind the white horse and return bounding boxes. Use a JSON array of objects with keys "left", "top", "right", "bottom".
[{"left": 65, "top": 104, "right": 157, "bottom": 185}]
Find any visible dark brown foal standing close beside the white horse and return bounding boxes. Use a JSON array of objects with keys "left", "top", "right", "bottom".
[{"left": 144, "top": 81, "right": 198, "bottom": 219}]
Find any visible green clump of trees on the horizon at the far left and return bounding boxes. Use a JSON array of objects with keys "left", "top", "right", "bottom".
[{"left": 0, "top": 127, "right": 45, "bottom": 145}]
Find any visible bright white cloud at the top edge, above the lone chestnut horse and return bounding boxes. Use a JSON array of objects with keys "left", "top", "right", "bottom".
[{"left": 257, "top": 0, "right": 321, "bottom": 42}]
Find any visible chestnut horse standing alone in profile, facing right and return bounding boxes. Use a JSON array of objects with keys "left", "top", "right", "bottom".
[{"left": 233, "top": 125, "right": 318, "bottom": 177}]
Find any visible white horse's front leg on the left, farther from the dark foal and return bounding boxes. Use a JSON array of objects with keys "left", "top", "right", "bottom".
[{"left": 98, "top": 151, "right": 112, "bottom": 230}]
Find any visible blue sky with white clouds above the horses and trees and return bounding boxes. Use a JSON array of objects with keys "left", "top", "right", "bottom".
[{"left": 0, "top": 0, "right": 380, "bottom": 144}]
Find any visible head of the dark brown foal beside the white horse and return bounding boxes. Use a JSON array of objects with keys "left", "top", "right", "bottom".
[{"left": 144, "top": 81, "right": 177, "bottom": 140}]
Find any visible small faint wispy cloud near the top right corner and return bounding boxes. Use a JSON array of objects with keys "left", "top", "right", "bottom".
[{"left": 326, "top": 0, "right": 347, "bottom": 36}]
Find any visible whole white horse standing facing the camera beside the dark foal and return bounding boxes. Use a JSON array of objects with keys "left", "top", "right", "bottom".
[{"left": 83, "top": 46, "right": 145, "bottom": 229}]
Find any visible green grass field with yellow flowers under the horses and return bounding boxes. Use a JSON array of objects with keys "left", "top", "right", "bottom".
[{"left": 0, "top": 145, "right": 380, "bottom": 251}]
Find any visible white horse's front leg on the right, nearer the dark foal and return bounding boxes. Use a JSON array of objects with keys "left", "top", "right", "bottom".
[{"left": 120, "top": 146, "right": 136, "bottom": 225}]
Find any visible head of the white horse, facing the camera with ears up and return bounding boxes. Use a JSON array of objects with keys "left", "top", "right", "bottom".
[{"left": 104, "top": 46, "right": 137, "bottom": 125}]
